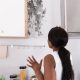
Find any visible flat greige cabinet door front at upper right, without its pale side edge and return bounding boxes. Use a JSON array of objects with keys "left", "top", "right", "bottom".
[{"left": 67, "top": 0, "right": 80, "bottom": 32}]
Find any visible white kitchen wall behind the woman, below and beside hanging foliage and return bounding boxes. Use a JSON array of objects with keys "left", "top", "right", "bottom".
[{"left": 0, "top": 0, "right": 80, "bottom": 80}]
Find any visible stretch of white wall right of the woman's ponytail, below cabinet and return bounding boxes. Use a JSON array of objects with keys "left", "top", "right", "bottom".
[{"left": 67, "top": 38, "right": 80, "bottom": 80}]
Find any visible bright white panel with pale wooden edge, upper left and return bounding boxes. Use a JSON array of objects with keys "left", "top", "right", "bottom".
[{"left": 0, "top": 0, "right": 27, "bottom": 37}]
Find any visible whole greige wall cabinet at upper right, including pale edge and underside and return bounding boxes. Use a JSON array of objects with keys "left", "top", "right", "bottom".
[{"left": 62, "top": 0, "right": 80, "bottom": 36}]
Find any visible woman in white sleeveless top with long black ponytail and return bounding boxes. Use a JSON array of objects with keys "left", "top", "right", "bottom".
[{"left": 27, "top": 27, "right": 74, "bottom": 80}]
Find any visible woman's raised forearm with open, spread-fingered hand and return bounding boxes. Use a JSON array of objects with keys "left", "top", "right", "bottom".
[{"left": 27, "top": 56, "right": 44, "bottom": 80}]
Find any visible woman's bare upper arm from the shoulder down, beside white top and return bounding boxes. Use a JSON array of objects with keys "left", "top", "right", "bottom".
[{"left": 44, "top": 54, "right": 56, "bottom": 80}]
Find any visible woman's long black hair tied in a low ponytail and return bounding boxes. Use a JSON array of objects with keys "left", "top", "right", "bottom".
[{"left": 48, "top": 27, "right": 74, "bottom": 80}]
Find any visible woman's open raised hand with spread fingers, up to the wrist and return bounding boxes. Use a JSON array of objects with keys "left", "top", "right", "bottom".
[{"left": 27, "top": 56, "right": 42, "bottom": 72}]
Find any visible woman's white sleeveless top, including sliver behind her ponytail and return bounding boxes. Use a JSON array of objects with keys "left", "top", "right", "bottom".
[{"left": 41, "top": 50, "right": 73, "bottom": 80}]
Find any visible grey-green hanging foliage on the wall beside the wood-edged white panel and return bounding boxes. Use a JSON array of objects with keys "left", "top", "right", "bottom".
[{"left": 27, "top": 0, "right": 46, "bottom": 37}]
